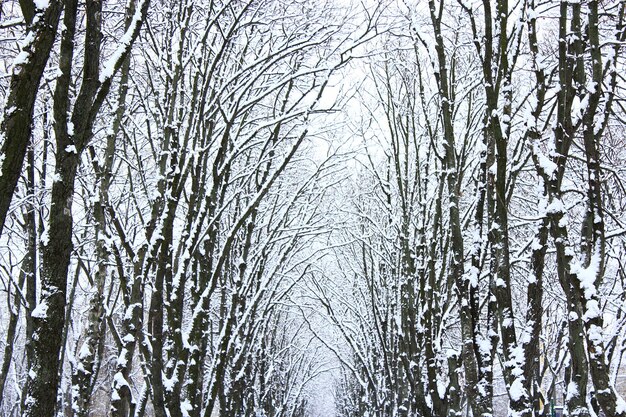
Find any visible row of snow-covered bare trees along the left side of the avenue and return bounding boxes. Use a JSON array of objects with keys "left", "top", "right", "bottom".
[{"left": 0, "top": 0, "right": 374, "bottom": 417}]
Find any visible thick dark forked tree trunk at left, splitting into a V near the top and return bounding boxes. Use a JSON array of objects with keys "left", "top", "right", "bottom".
[{"left": 24, "top": 0, "right": 149, "bottom": 416}]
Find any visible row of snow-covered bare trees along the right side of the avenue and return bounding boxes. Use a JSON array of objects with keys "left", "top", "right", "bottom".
[{"left": 322, "top": 0, "right": 626, "bottom": 417}]
